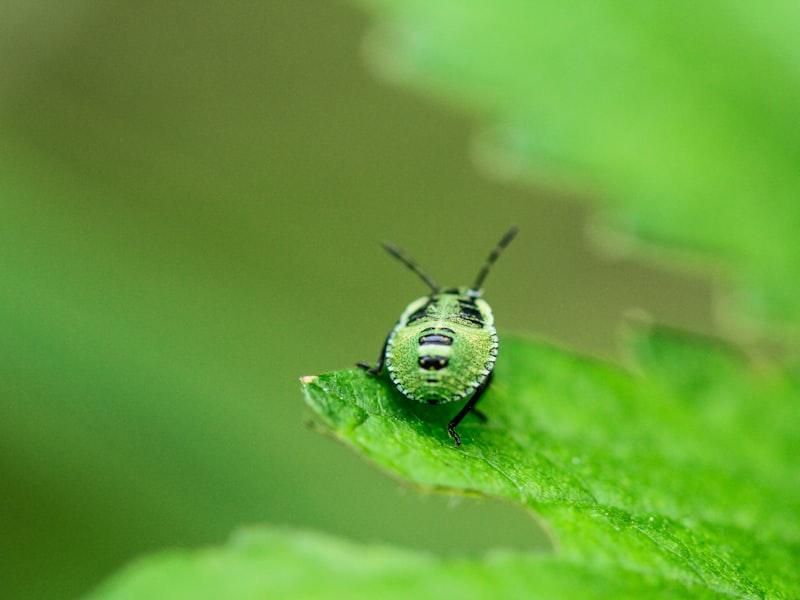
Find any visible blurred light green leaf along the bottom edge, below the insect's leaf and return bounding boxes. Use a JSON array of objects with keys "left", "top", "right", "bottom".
[{"left": 86, "top": 528, "right": 713, "bottom": 600}]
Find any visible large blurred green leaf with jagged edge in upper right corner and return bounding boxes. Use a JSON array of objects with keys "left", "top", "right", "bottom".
[{"left": 355, "top": 0, "right": 800, "bottom": 324}]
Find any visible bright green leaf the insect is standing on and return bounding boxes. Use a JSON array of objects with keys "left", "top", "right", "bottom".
[{"left": 305, "top": 331, "right": 800, "bottom": 598}]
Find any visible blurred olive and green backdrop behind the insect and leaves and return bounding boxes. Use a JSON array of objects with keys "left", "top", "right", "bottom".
[{"left": 0, "top": 0, "right": 714, "bottom": 598}]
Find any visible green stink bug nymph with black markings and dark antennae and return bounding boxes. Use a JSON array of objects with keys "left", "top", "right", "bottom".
[{"left": 357, "top": 227, "right": 517, "bottom": 446}]
